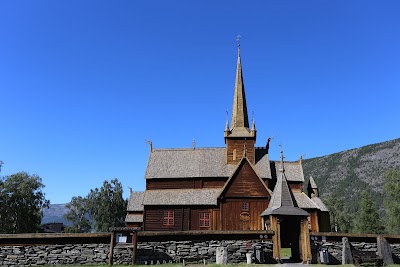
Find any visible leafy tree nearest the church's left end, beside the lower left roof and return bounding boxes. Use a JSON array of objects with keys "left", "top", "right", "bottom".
[{"left": 87, "top": 179, "right": 128, "bottom": 232}]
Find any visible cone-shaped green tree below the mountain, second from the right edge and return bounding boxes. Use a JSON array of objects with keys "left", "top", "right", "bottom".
[{"left": 354, "top": 191, "right": 384, "bottom": 234}]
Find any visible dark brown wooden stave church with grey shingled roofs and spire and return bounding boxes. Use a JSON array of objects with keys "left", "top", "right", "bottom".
[{"left": 126, "top": 45, "right": 330, "bottom": 238}]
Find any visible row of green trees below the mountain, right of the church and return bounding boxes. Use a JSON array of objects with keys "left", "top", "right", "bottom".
[{"left": 325, "top": 170, "right": 400, "bottom": 234}]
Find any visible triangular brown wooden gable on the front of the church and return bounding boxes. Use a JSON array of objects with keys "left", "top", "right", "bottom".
[{"left": 221, "top": 158, "right": 270, "bottom": 198}]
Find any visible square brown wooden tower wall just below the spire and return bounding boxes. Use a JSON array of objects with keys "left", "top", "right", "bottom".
[{"left": 226, "top": 139, "right": 256, "bottom": 164}]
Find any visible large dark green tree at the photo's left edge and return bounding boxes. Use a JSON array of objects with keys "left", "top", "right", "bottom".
[{"left": 0, "top": 172, "right": 50, "bottom": 234}]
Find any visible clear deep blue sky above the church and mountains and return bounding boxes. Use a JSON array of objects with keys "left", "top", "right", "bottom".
[{"left": 0, "top": 0, "right": 400, "bottom": 204}]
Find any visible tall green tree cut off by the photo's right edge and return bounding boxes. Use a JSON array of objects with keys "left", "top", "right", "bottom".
[{"left": 383, "top": 170, "right": 400, "bottom": 235}]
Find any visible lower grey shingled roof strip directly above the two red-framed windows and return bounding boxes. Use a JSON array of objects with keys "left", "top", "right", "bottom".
[{"left": 143, "top": 188, "right": 221, "bottom": 206}]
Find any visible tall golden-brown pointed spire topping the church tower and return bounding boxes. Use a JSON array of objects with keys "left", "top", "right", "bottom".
[{"left": 231, "top": 40, "right": 249, "bottom": 130}]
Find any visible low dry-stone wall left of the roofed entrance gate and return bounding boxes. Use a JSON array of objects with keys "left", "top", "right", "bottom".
[{"left": 0, "top": 241, "right": 272, "bottom": 267}]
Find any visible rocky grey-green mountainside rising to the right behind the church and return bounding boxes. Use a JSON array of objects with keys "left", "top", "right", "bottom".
[{"left": 303, "top": 138, "right": 400, "bottom": 213}]
